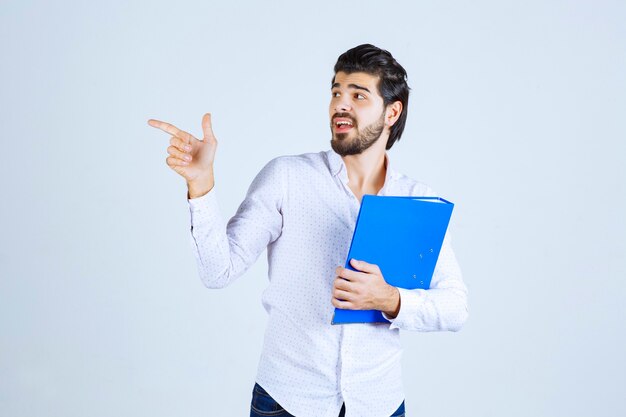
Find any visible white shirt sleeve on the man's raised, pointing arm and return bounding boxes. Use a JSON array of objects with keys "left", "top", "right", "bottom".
[{"left": 188, "top": 158, "right": 284, "bottom": 288}]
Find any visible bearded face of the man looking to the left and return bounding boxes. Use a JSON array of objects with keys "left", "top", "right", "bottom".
[{"left": 329, "top": 71, "right": 386, "bottom": 156}]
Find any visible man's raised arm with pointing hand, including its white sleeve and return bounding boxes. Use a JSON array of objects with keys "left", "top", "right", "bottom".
[{"left": 148, "top": 113, "right": 283, "bottom": 288}]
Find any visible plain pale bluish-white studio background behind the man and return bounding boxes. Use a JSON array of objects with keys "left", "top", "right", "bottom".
[{"left": 0, "top": 0, "right": 626, "bottom": 417}]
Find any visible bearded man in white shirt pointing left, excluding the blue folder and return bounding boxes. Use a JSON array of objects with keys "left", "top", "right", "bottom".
[{"left": 149, "top": 45, "right": 467, "bottom": 417}]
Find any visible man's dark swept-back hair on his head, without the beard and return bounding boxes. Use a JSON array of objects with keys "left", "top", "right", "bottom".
[{"left": 333, "top": 43, "right": 410, "bottom": 150}]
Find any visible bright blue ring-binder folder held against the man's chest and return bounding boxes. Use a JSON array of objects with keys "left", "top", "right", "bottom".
[{"left": 332, "top": 195, "right": 454, "bottom": 324}]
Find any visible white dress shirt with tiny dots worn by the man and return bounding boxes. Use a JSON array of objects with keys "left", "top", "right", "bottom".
[{"left": 189, "top": 150, "right": 468, "bottom": 417}]
